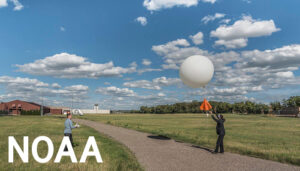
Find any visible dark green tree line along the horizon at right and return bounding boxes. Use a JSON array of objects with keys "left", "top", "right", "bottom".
[{"left": 137, "top": 96, "right": 300, "bottom": 114}]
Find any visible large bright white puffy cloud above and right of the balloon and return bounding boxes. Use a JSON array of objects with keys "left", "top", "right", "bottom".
[{"left": 210, "top": 16, "right": 280, "bottom": 48}]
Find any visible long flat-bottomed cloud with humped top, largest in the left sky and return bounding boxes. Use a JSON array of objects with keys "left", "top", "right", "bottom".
[{"left": 16, "top": 53, "right": 137, "bottom": 78}]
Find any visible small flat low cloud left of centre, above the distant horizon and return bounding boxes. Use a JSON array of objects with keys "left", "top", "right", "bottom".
[{"left": 96, "top": 86, "right": 136, "bottom": 97}]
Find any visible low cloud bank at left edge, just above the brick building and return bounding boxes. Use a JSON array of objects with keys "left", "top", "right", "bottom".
[{"left": 0, "top": 76, "right": 89, "bottom": 103}]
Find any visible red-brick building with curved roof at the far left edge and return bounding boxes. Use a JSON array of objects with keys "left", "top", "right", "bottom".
[{"left": 0, "top": 100, "right": 50, "bottom": 115}]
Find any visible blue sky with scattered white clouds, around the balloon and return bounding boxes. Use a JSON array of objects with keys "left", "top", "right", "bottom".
[{"left": 0, "top": 0, "right": 300, "bottom": 110}]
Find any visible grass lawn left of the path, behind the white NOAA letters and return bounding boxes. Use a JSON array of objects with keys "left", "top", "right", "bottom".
[{"left": 0, "top": 116, "right": 142, "bottom": 171}]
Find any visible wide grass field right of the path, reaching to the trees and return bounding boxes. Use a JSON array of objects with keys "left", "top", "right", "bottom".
[{"left": 80, "top": 114, "right": 300, "bottom": 165}]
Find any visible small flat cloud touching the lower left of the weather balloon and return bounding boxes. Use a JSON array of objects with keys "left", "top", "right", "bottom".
[{"left": 123, "top": 77, "right": 181, "bottom": 90}]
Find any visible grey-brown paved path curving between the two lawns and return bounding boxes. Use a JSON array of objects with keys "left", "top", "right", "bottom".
[{"left": 74, "top": 119, "right": 300, "bottom": 171}]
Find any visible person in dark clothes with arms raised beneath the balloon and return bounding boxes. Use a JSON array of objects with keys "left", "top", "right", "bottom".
[{"left": 211, "top": 115, "right": 225, "bottom": 153}]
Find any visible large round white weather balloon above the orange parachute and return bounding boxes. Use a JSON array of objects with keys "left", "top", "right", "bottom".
[{"left": 180, "top": 55, "right": 214, "bottom": 88}]
